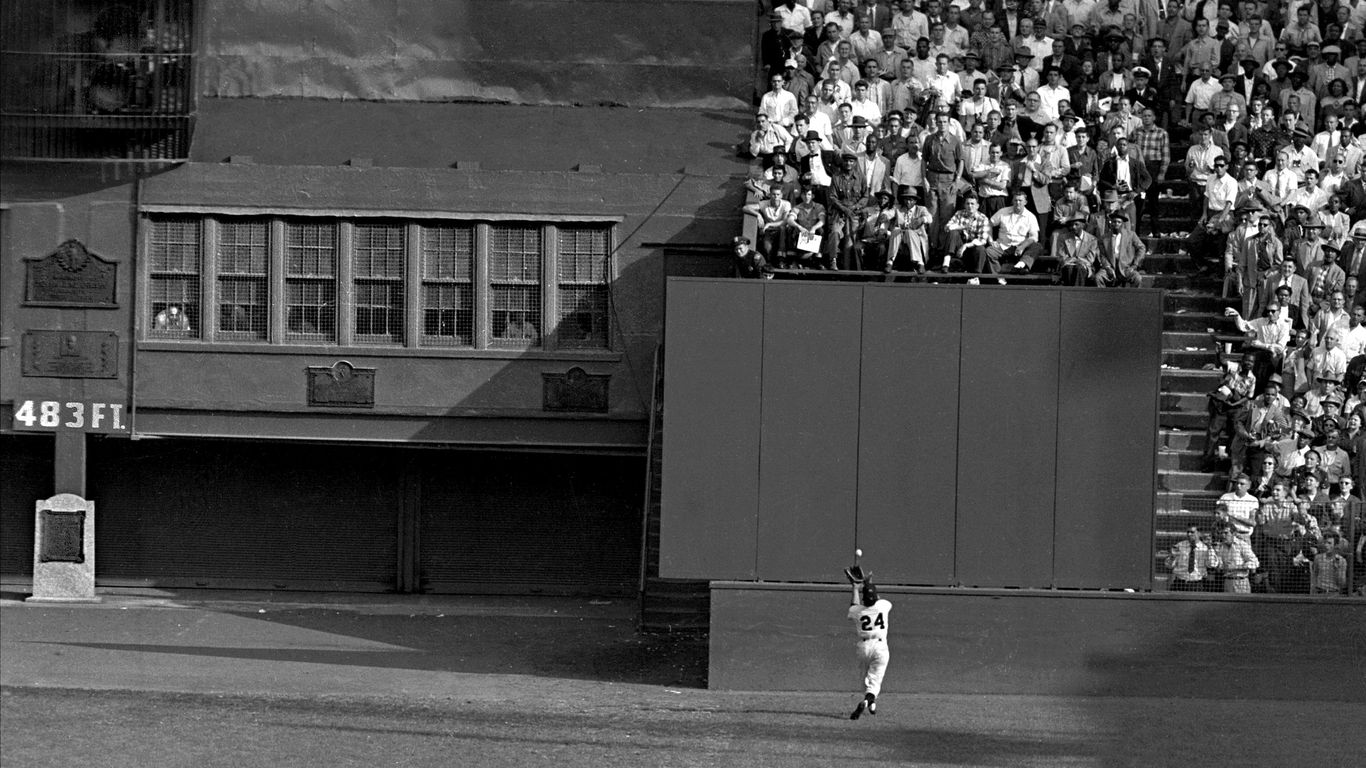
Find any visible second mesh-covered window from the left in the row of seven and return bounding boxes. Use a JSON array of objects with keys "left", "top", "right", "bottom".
[{"left": 217, "top": 219, "right": 270, "bottom": 342}]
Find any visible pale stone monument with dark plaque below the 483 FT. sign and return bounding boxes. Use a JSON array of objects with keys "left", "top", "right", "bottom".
[{"left": 29, "top": 493, "right": 100, "bottom": 603}]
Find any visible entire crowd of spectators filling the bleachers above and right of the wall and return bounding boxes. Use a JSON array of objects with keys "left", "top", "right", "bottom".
[{"left": 735, "top": 0, "right": 1366, "bottom": 592}]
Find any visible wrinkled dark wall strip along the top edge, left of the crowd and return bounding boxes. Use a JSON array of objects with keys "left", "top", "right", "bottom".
[{"left": 199, "top": 0, "right": 755, "bottom": 109}]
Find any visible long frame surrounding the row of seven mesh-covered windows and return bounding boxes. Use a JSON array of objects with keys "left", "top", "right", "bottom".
[{"left": 137, "top": 211, "right": 622, "bottom": 359}]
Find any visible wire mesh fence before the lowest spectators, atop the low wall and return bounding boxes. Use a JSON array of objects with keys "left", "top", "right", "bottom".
[{"left": 1156, "top": 492, "right": 1366, "bottom": 597}]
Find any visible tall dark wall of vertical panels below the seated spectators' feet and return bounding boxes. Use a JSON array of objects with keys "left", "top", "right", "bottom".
[{"left": 660, "top": 279, "right": 1161, "bottom": 589}]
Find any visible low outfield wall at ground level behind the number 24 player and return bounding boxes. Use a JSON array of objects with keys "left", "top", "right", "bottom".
[{"left": 708, "top": 582, "right": 1366, "bottom": 696}]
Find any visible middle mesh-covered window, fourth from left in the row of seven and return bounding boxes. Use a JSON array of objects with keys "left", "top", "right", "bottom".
[{"left": 351, "top": 224, "right": 407, "bottom": 344}]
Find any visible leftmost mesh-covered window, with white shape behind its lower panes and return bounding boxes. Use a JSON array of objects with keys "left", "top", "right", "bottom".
[{"left": 148, "top": 216, "right": 202, "bottom": 339}]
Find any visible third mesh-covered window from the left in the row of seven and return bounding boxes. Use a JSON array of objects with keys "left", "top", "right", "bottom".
[{"left": 284, "top": 221, "right": 337, "bottom": 343}]
